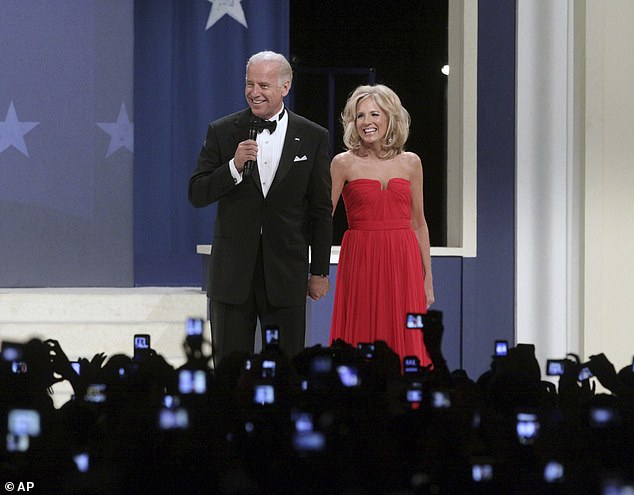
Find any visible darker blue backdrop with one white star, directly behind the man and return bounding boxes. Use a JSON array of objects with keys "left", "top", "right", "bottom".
[{"left": 134, "top": 0, "right": 289, "bottom": 286}]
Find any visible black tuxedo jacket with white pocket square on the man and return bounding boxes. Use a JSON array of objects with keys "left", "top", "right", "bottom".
[{"left": 189, "top": 109, "right": 332, "bottom": 307}]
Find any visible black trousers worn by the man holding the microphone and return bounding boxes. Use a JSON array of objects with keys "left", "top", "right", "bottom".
[{"left": 209, "top": 245, "right": 308, "bottom": 366}]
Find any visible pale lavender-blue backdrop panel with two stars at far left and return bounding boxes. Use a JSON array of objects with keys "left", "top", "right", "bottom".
[{"left": 0, "top": 0, "right": 133, "bottom": 287}]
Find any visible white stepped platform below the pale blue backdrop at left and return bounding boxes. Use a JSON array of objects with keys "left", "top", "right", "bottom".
[{"left": 0, "top": 287, "right": 210, "bottom": 405}]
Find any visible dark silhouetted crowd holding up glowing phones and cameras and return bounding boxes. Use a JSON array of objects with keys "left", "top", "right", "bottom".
[{"left": 0, "top": 311, "right": 634, "bottom": 495}]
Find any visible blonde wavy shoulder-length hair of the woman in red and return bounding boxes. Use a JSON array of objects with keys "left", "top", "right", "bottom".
[{"left": 341, "top": 84, "right": 411, "bottom": 158}]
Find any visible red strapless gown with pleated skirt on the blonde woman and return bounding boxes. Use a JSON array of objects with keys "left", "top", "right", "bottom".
[{"left": 330, "top": 178, "right": 431, "bottom": 366}]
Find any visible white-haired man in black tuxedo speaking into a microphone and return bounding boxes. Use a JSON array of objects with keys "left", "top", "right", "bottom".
[{"left": 189, "top": 52, "right": 332, "bottom": 365}]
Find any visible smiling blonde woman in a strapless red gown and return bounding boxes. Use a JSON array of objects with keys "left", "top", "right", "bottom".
[{"left": 330, "top": 85, "right": 434, "bottom": 366}]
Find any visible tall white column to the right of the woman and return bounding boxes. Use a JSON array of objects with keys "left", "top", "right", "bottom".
[{"left": 516, "top": 0, "right": 582, "bottom": 371}]
